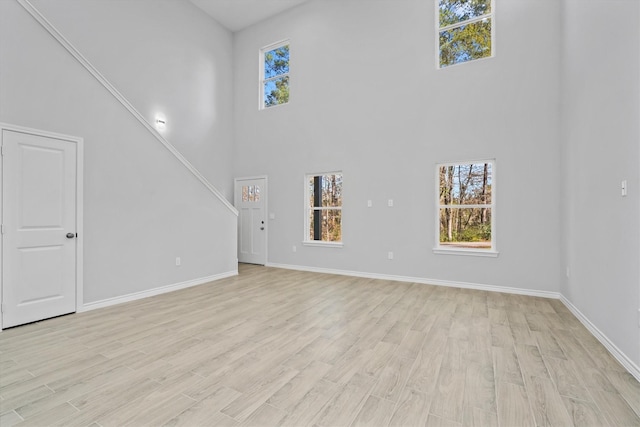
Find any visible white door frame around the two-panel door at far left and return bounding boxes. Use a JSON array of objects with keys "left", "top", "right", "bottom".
[{"left": 0, "top": 122, "right": 84, "bottom": 332}]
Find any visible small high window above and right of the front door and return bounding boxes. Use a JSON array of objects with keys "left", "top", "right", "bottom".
[{"left": 260, "top": 41, "right": 289, "bottom": 109}]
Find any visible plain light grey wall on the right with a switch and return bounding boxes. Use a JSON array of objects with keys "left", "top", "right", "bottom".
[{"left": 562, "top": 0, "right": 640, "bottom": 366}]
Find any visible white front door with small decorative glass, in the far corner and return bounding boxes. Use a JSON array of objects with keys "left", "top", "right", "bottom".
[{"left": 234, "top": 178, "right": 267, "bottom": 265}]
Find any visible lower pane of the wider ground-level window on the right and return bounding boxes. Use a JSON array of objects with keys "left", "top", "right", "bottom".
[{"left": 440, "top": 208, "right": 491, "bottom": 249}]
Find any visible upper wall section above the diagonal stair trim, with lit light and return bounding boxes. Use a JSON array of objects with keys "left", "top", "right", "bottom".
[{"left": 32, "top": 0, "right": 233, "bottom": 199}]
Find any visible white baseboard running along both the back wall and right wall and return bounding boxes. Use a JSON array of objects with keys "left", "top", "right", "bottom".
[{"left": 267, "top": 263, "right": 640, "bottom": 381}]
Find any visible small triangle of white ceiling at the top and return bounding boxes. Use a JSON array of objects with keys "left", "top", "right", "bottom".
[{"left": 190, "top": 0, "right": 308, "bottom": 32}]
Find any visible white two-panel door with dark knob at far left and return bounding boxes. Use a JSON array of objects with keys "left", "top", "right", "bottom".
[{"left": 2, "top": 129, "right": 78, "bottom": 328}]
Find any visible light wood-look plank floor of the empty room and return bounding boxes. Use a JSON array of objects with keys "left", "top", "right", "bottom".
[{"left": 0, "top": 265, "right": 640, "bottom": 427}]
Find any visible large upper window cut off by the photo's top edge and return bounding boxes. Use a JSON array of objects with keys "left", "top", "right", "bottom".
[{"left": 436, "top": 0, "right": 494, "bottom": 68}]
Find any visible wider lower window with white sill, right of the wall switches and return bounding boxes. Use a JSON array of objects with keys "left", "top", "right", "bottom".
[{"left": 436, "top": 160, "right": 495, "bottom": 252}]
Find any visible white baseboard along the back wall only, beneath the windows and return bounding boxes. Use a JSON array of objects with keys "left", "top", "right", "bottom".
[{"left": 266, "top": 263, "right": 560, "bottom": 299}]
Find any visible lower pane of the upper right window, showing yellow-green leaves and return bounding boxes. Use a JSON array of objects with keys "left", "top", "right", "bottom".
[{"left": 440, "top": 19, "right": 491, "bottom": 67}]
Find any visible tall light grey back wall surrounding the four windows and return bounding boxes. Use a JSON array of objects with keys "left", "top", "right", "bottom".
[{"left": 234, "top": 0, "right": 564, "bottom": 292}]
